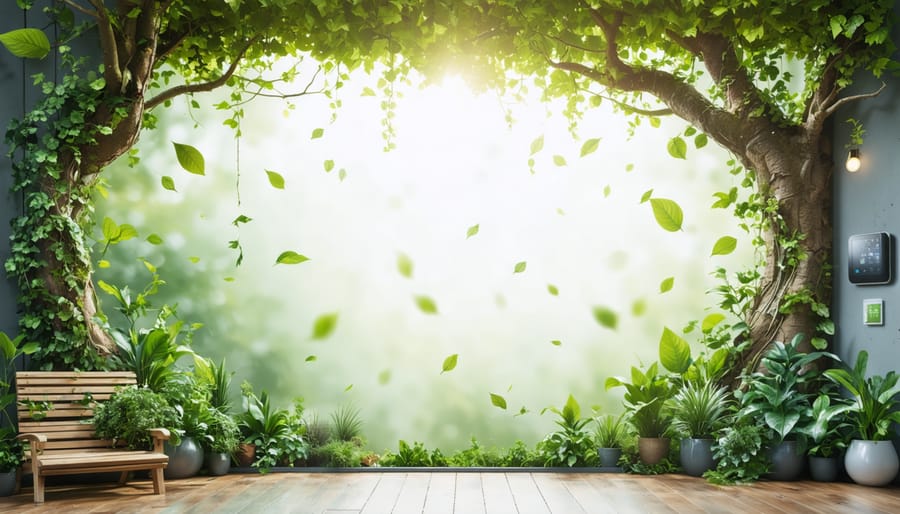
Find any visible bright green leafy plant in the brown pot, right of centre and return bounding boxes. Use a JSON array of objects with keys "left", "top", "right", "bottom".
[{"left": 606, "top": 362, "right": 673, "bottom": 465}]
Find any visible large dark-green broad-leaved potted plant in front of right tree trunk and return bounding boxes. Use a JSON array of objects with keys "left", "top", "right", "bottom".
[{"left": 738, "top": 334, "right": 838, "bottom": 480}]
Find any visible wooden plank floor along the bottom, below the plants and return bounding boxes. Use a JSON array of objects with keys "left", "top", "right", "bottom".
[{"left": 0, "top": 472, "right": 900, "bottom": 514}]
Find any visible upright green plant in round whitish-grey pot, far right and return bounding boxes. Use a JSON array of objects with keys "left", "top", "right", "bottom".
[{"left": 825, "top": 350, "right": 900, "bottom": 486}]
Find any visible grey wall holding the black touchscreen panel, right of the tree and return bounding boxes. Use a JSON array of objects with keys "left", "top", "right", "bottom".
[{"left": 832, "top": 6, "right": 900, "bottom": 374}]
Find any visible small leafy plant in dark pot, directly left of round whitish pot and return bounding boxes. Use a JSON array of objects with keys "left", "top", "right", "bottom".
[{"left": 800, "top": 393, "right": 850, "bottom": 482}]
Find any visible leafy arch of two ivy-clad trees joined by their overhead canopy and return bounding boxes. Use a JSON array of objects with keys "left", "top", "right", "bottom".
[{"left": 7, "top": 0, "right": 894, "bottom": 372}]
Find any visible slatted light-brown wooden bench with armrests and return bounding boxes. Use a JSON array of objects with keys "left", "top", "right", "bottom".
[{"left": 16, "top": 371, "right": 169, "bottom": 503}]
